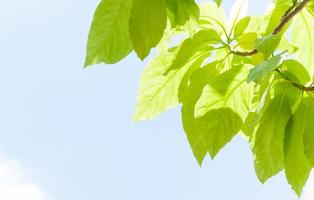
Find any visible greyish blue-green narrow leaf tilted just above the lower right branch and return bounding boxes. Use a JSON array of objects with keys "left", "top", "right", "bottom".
[{"left": 248, "top": 56, "right": 283, "bottom": 82}]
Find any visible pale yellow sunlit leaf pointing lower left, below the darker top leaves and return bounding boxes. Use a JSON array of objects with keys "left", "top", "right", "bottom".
[{"left": 134, "top": 52, "right": 204, "bottom": 122}]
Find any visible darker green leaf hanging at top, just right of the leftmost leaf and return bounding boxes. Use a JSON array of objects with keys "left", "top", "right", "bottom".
[{"left": 130, "top": 0, "right": 167, "bottom": 60}]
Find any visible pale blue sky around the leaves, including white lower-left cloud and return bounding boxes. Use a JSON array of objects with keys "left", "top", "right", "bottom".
[{"left": 0, "top": 0, "right": 312, "bottom": 200}]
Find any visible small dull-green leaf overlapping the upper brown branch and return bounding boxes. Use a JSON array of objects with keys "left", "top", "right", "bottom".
[{"left": 256, "top": 35, "right": 281, "bottom": 59}]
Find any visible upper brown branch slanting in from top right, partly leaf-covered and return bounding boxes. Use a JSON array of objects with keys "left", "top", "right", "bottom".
[{"left": 230, "top": 0, "right": 311, "bottom": 56}]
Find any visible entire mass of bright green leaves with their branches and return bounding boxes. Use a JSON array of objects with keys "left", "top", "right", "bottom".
[{"left": 86, "top": 0, "right": 314, "bottom": 195}]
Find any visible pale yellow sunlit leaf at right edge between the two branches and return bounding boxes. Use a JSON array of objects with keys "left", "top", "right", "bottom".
[{"left": 291, "top": 11, "right": 314, "bottom": 78}]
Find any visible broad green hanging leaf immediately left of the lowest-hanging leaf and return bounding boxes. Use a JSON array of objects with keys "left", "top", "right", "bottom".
[{"left": 251, "top": 92, "right": 291, "bottom": 183}]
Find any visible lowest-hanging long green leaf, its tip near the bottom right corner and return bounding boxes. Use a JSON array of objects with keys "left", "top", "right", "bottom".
[{"left": 284, "top": 98, "right": 314, "bottom": 196}]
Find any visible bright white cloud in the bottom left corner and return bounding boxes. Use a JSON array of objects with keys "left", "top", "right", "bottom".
[{"left": 0, "top": 154, "right": 46, "bottom": 200}]
